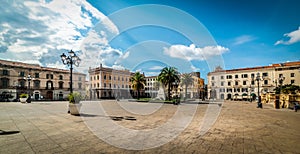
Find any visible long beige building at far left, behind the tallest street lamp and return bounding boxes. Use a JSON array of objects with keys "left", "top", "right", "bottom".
[{"left": 0, "top": 60, "right": 86, "bottom": 101}]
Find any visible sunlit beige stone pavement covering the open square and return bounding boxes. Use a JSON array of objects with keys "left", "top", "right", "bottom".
[{"left": 0, "top": 101, "right": 300, "bottom": 154}]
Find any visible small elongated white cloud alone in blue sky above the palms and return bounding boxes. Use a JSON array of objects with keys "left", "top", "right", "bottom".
[{"left": 164, "top": 44, "right": 229, "bottom": 61}]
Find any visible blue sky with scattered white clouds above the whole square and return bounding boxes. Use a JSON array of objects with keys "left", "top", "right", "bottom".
[{"left": 0, "top": 0, "right": 300, "bottom": 78}]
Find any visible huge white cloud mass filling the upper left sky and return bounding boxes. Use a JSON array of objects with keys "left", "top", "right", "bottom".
[{"left": 0, "top": 0, "right": 120, "bottom": 70}]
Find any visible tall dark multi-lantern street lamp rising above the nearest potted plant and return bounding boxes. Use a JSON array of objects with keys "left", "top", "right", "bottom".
[{"left": 60, "top": 50, "right": 81, "bottom": 93}]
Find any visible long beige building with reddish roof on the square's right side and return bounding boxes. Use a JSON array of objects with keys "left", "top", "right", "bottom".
[{"left": 207, "top": 61, "right": 300, "bottom": 100}]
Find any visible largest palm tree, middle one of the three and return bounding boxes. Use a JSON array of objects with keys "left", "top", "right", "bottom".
[{"left": 158, "top": 67, "right": 180, "bottom": 100}]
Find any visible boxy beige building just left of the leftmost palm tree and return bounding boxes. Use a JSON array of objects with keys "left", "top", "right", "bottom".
[{"left": 89, "top": 64, "right": 132, "bottom": 99}]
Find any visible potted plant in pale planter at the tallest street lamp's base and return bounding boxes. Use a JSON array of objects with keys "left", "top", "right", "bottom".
[{"left": 68, "top": 92, "right": 82, "bottom": 115}]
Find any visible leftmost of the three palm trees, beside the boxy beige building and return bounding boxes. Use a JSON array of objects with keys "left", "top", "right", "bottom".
[{"left": 130, "top": 72, "right": 146, "bottom": 99}]
